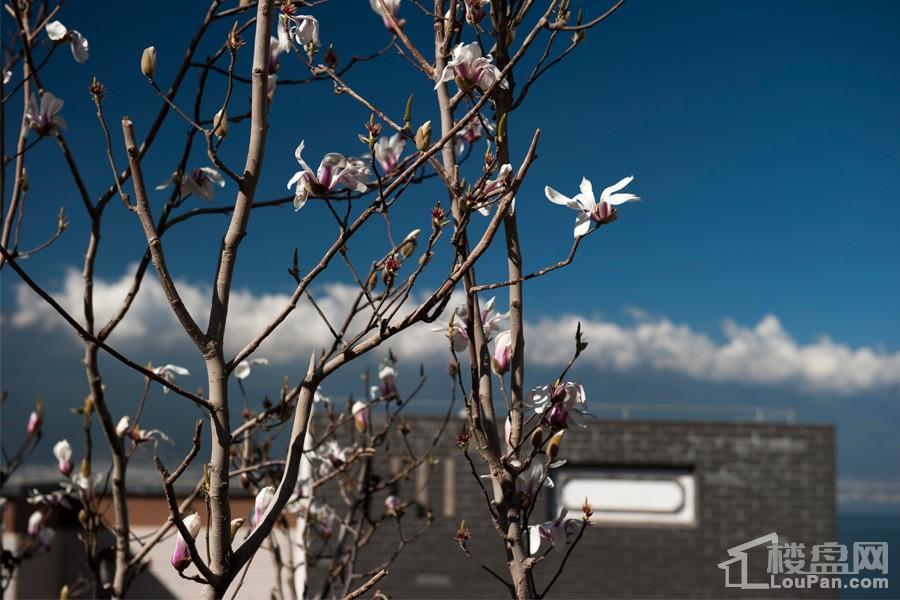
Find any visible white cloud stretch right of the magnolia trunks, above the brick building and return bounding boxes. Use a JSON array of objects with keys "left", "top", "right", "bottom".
[{"left": 528, "top": 315, "right": 900, "bottom": 394}]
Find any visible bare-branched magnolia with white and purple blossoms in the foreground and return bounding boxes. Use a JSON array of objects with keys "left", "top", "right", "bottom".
[{"left": 0, "top": 0, "right": 638, "bottom": 598}]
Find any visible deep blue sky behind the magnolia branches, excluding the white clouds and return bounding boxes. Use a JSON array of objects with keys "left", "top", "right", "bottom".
[{"left": 2, "top": 0, "right": 900, "bottom": 492}]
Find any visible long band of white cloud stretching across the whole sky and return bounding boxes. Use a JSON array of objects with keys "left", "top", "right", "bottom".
[{"left": 8, "top": 269, "right": 900, "bottom": 394}]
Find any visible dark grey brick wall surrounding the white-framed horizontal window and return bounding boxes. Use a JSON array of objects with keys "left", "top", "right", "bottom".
[{"left": 350, "top": 419, "right": 836, "bottom": 598}]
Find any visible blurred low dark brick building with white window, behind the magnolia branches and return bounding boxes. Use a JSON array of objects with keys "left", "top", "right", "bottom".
[{"left": 3, "top": 406, "right": 838, "bottom": 598}]
